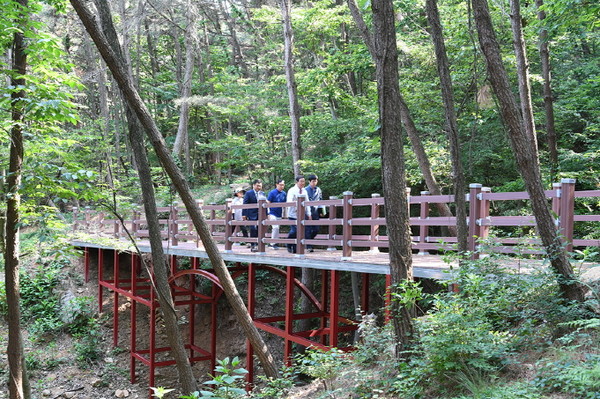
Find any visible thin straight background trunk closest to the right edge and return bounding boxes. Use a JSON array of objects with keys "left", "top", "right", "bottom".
[{"left": 535, "top": 0, "right": 558, "bottom": 181}]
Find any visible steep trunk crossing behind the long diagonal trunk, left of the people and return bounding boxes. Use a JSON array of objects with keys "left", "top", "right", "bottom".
[{"left": 95, "top": 0, "right": 197, "bottom": 394}]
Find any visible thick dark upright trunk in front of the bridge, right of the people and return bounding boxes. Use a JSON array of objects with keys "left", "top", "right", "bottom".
[{"left": 371, "top": 0, "right": 414, "bottom": 357}]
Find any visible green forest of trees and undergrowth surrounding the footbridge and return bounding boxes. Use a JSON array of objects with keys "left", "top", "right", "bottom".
[{"left": 0, "top": 0, "right": 600, "bottom": 399}]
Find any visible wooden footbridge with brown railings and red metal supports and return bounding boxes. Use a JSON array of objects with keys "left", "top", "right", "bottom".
[{"left": 73, "top": 179, "right": 600, "bottom": 392}]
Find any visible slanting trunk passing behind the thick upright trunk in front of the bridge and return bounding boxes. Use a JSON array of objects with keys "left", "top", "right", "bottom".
[{"left": 347, "top": 0, "right": 457, "bottom": 230}]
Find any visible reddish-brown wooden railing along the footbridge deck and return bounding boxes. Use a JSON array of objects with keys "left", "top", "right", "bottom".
[{"left": 73, "top": 179, "right": 600, "bottom": 260}]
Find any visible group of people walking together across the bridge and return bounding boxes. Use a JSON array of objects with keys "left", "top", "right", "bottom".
[{"left": 232, "top": 175, "right": 325, "bottom": 253}]
